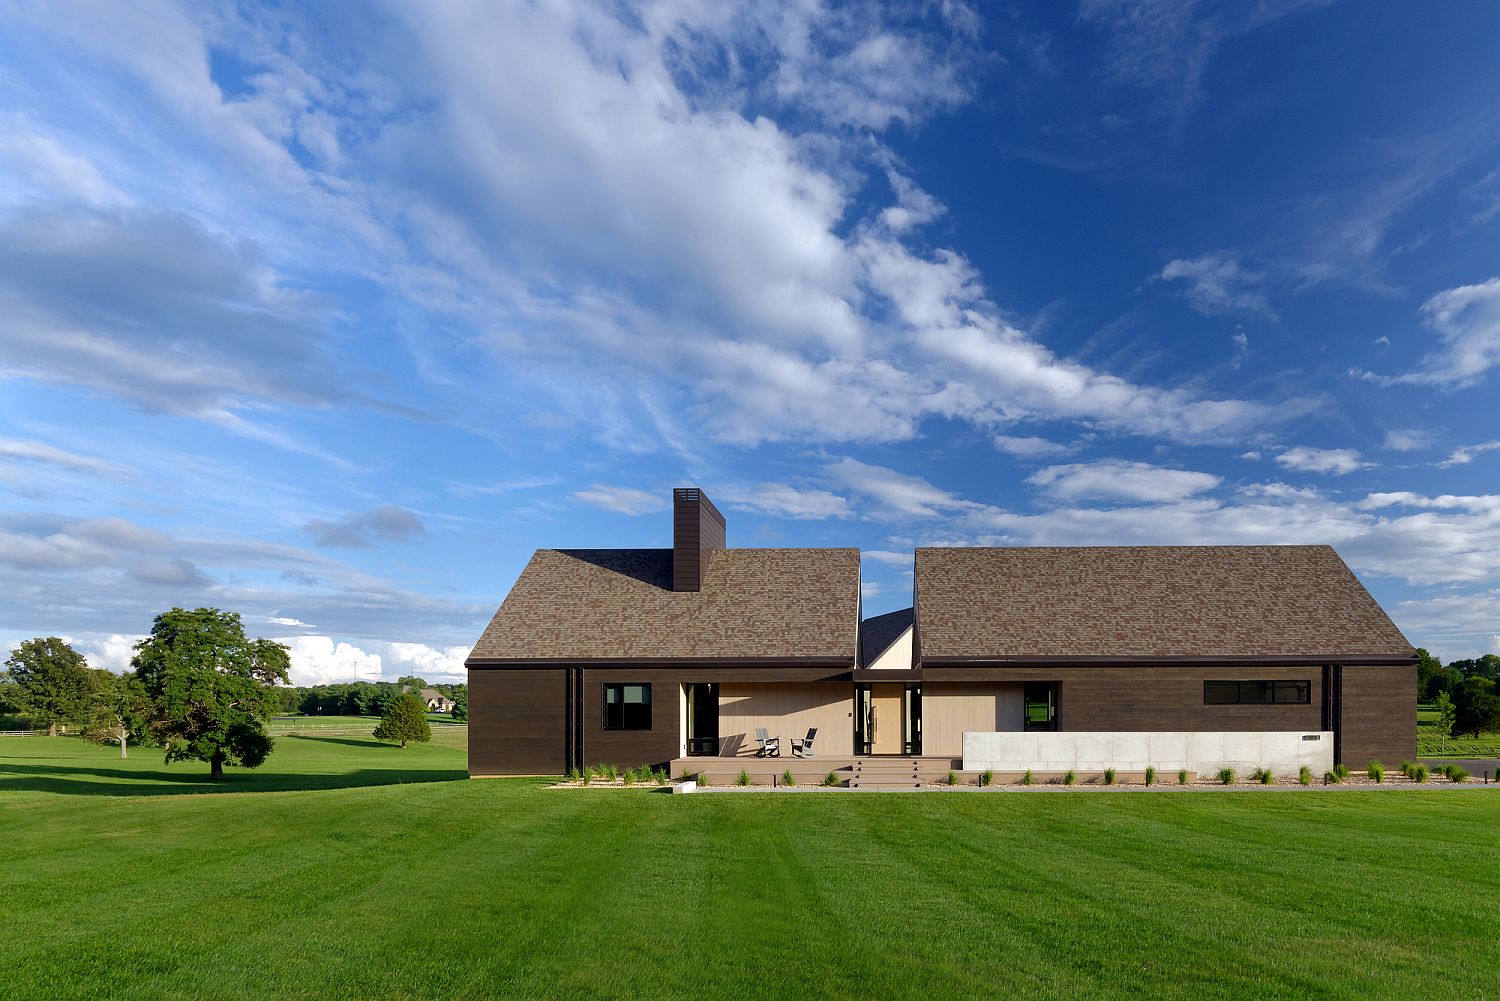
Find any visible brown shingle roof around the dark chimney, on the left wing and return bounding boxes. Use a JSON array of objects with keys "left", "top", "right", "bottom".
[{"left": 470, "top": 549, "right": 860, "bottom": 662}]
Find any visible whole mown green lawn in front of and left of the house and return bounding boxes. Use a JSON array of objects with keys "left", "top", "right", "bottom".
[{"left": 0, "top": 735, "right": 1500, "bottom": 1001}]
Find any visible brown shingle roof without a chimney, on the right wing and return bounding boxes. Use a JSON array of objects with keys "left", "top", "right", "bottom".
[{"left": 917, "top": 546, "right": 1413, "bottom": 660}]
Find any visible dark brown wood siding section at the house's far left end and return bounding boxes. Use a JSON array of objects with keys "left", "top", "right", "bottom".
[{"left": 468, "top": 668, "right": 567, "bottom": 774}]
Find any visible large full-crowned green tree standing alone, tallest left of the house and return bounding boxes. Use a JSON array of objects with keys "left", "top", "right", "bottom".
[{"left": 131, "top": 608, "right": 291, "bottom": 782}]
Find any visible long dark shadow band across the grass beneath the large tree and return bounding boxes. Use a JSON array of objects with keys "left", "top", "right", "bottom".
[{"left": 0, "top": 762, "right": 468, "bottom": 795}]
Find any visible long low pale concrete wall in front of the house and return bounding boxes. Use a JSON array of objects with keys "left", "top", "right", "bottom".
[{"left": 963, "top": 731, "right": 1334, "bottom": 776}]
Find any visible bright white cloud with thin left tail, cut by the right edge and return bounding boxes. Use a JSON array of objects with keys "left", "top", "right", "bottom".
[{"left": 1350, "top": 278, "right": 1500, "bottom": 386}]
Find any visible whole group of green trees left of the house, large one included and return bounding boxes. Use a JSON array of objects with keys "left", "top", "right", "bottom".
[{"left": 0, "top": 608, "right": 453, "bottom": 780}]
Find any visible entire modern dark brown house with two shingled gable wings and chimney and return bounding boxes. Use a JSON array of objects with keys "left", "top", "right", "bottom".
[{"left": 467, "top": 489, "right": 1416, "bottom": 776}]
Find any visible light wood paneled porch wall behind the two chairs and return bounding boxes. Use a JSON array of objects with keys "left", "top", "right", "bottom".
[{"left": 719, "top": 683, "right": 854, "bottom": 758}]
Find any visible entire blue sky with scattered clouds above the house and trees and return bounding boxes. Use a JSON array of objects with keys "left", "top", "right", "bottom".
[{"left": 0, "top": 2, "right": 1500, "bottom": 681}]
